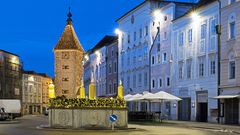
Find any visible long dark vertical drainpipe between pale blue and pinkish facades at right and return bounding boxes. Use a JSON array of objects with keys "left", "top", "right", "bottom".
[{"left": 216, "top": 0, "right": 222, "bottom": 124}]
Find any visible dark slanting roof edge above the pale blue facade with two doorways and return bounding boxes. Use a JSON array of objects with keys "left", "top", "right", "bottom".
[{"left": 173, "top": 0, "right": 217, "bottom": 21}]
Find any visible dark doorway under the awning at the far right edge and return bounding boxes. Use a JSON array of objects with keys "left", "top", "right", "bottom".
[{"left": 225, "top": 98, "right": 239, "bottom": 124}]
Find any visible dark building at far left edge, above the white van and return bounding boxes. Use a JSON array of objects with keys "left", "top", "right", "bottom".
[{"left": 0, "top": 50, "right": 22, "bottom": 99}]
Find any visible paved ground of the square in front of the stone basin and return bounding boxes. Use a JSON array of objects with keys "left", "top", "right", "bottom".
[{"left": 0, "top": 116, "right": 238, "bottom": 135}]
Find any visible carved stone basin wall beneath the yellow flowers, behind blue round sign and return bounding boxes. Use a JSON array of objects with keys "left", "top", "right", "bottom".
[{"left": 49, "top": 108, "right": 128, "bottom": 129}]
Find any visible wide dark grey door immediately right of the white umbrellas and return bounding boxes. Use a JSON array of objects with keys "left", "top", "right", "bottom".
[{"left": 178, "top": 98, "right": 191, "bottom": 121}]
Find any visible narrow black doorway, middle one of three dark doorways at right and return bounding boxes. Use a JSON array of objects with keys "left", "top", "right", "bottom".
[{"left": 197, "top": 103, "right": 208, "bottom": 122}]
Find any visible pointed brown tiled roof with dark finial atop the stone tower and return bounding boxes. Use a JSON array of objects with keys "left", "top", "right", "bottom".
[{"left": 54, "top": 8, "right": 84, "bottom": 51}]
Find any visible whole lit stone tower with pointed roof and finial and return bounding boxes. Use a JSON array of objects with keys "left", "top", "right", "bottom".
[{"left": 54, "top": 8, "right": 84, "bottom": 98}]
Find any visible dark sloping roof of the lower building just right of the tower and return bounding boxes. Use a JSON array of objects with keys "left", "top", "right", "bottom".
[{"left": 91, "top": 35, "right": 118, "bottom": 52}]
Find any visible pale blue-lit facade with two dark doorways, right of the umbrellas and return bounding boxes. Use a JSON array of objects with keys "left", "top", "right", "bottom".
[{"left": 171, "top": 0, "right": 219, "bottom": 122}]
